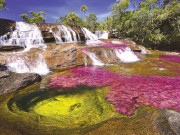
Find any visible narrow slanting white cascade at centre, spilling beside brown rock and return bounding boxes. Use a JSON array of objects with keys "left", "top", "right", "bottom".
[{"left": 82, "top": 49, "right": 104, "bottom": 66}]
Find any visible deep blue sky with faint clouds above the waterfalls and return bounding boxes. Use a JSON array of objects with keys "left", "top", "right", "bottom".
[{"left": 0, "top": 0, "right": 119, "bottom": 23}]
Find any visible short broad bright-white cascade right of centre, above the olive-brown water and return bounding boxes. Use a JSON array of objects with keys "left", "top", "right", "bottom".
[{"left": 115, "top": 47, "right": 139, "bottom": 63}]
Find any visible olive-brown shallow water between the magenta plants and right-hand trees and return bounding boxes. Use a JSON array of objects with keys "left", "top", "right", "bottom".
[{"left": 103, "top": 54, "right": 180, "bottom": 76}]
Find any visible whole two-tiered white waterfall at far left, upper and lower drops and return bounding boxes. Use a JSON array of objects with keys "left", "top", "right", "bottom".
[{"left": 0, "top": 22, "right": 49, "bottom": 75}]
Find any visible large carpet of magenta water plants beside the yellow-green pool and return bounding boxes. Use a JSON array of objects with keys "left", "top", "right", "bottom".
[{"left": 49, "top": 67, "right": 180, "bottom": 115}]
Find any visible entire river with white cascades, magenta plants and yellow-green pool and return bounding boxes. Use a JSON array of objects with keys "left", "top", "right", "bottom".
[{"left": 0, "top": 23, "right": 180, "bottom": 135}]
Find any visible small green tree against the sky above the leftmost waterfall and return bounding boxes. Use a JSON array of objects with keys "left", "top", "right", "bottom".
[{"left": 20, "top": 11, "right": 46, "bottom": 23}]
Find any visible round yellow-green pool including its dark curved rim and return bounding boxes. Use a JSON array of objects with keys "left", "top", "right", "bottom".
[{"left": 0, "top": 84, "right": 120, "bottom": 135}]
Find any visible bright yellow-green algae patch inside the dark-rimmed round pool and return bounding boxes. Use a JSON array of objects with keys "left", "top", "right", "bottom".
[{"left": 29, "top": 87, "right": 117, "bottom": 128}]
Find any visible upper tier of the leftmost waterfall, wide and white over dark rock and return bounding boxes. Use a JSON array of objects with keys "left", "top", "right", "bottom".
[{"left": 0, "top": 22, "right": 46, "bottom": 50}]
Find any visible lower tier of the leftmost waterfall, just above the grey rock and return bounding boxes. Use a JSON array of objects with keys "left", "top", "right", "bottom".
[{"left": 5, "top": 53, "right": 49, "bottom": 75}]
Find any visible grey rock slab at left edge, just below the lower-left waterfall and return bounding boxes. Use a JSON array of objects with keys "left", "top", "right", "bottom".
[{"left": 0, "top": 71, "right": 41, "bottom": 95}]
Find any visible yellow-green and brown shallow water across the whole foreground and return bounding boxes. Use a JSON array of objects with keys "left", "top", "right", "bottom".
[{"left": 0, "top": 84, "right": 167, "bottom": 135}]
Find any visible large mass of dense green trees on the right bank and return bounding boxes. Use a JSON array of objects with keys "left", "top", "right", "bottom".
[{"left": 109, "top": 0, "right": 180, "bottom": 47}]
